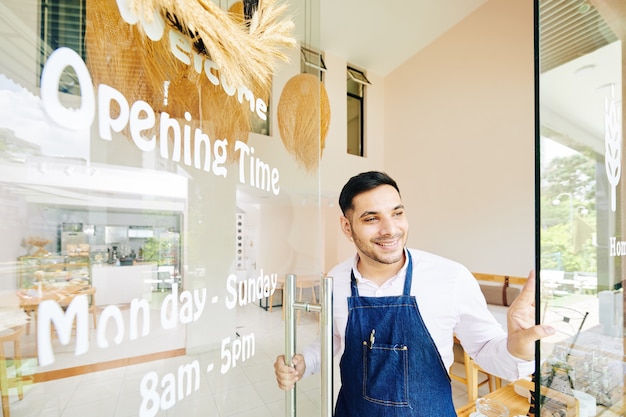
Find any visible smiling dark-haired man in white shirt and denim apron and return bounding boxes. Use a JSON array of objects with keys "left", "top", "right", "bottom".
[{"left": 274, "top": 172, "right": 554, "bottom": 417}]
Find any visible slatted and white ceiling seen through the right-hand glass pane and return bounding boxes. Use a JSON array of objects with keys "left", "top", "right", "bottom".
[{"left": 539, "top": 0, "right": 623, "bottom": 155}]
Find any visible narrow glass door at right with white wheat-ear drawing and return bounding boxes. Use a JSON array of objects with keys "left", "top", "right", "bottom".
[{"left": 535, "top": 0, "right": 626, "bottom": 416}]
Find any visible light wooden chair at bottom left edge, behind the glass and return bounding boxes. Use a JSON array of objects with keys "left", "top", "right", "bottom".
[{"left": 0, "top": 326, "right": 32, "bottom": 417}]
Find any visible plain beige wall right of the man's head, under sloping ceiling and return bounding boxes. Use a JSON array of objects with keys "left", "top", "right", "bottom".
[{"left": 380, "top": 0, "right": 534, "bottom": 275}]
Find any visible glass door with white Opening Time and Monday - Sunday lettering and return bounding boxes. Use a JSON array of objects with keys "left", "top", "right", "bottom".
[{"left": 0, "top": 0, "right": 324, "bottom": 417}]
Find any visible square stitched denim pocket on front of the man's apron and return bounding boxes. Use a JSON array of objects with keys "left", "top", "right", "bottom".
[{"left": 363, "top": 342, "right": 409, "bottom": 407}]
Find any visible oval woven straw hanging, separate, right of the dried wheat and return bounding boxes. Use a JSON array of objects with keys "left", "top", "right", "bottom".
[{"left": 277, "top": 74, "right": 330, "bottom": 171}]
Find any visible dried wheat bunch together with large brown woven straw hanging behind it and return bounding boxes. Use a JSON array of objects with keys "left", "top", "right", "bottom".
[{"left": 85, "top": 0, "right": 296, "bottom": 159}]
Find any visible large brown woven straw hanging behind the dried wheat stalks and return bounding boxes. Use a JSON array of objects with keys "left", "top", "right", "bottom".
[{"left": 85, "top": 0, "right": 278, "bottom": 161}]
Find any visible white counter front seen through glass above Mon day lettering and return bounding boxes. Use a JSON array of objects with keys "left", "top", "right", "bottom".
[{"left": 91, "top": 263, "right": 157, "bottom": 306}]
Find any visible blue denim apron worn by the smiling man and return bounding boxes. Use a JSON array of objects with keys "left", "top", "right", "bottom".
[{"left": 335, "top": 251, "right": 456, "bottom": 417}]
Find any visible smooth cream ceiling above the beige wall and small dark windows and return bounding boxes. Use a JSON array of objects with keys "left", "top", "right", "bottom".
[{"left": 316, "top": 0, "right": 487, "bottom": 77}]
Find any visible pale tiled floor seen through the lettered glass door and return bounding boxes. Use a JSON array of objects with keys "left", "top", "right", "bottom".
[{"left": 4, "top": 298, "right": 478, "bottom": 417}]
